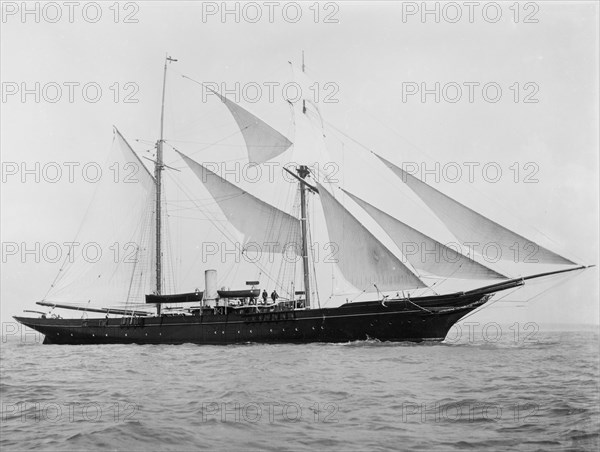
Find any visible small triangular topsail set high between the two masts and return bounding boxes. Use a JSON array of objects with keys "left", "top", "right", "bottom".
[{"left": 207, "top": 88, "right": 292, "bottom": 164}]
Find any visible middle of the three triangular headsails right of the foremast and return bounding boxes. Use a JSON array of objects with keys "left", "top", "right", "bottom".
[{"left": 344, "top": 190, "right": 506, "bottom": 279}]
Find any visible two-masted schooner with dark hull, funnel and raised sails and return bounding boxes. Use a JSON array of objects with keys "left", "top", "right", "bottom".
[{"left": 15, "top": 56, "right": 587, "bottom": 344}]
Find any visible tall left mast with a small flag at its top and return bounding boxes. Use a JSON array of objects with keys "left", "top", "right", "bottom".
[{"left": 154, "top": 55, "right": 177, "bottom": 314}]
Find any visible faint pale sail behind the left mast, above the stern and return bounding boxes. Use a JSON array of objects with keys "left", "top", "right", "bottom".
[{"left": 45, "top": 128, "right": 156, "bottom": 305}]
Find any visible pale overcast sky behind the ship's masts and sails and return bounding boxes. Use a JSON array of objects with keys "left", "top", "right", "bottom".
[{"left": 0, "top": 1, "right": 599, "bottom": 324}]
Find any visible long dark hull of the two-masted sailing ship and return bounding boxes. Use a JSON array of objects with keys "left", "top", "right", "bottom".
[{"left": 15, "top": 294, "right": 490, "bottom": 344}]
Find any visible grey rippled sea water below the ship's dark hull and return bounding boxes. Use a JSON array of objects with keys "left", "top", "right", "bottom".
[{"left": 0, "top": 327, "right": 600, "bottom": 451}]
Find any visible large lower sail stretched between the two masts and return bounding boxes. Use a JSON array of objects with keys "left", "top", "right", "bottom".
[{"left": 178, "top": 152, "right": 300, "bottom": 253}]
